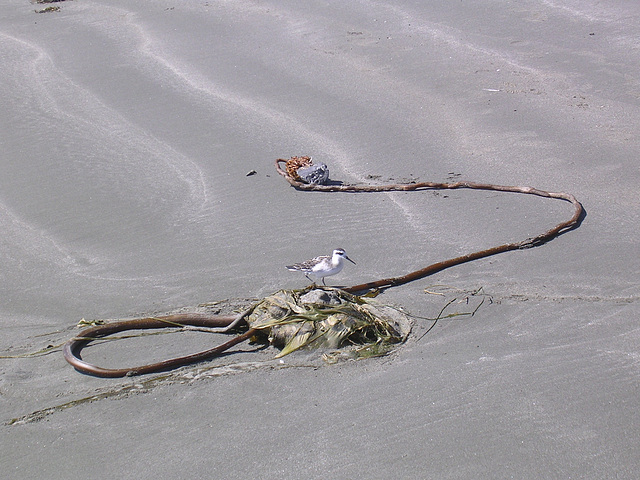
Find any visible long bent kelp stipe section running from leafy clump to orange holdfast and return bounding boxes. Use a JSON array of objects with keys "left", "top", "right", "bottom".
[{"left": 276, "top": 157, "right": 584, "bottom": 293}]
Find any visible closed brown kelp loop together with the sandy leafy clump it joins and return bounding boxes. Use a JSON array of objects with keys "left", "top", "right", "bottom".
[{"left": 63, "top": 285, "right": 411, "bottom": 377}]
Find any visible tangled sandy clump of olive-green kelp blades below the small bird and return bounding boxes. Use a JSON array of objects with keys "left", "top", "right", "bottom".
[{"left": 246, "top": 286, "right": 411, "bottom": 360}]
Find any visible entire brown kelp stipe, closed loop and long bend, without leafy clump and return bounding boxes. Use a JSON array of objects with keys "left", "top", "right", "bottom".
[{"left": 63, "top": 157, "right": 585, "bottom": 377}]
